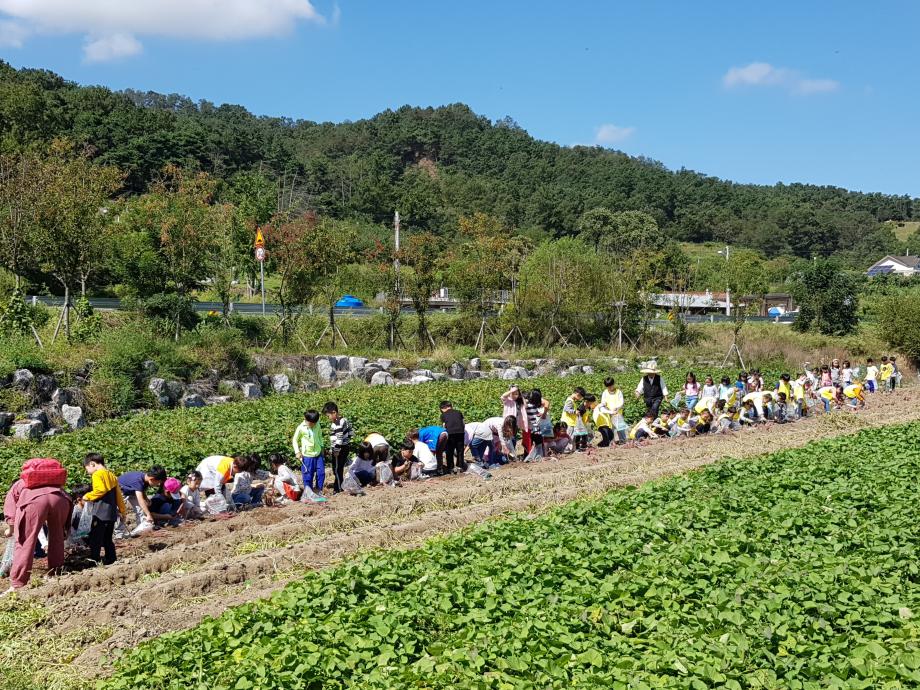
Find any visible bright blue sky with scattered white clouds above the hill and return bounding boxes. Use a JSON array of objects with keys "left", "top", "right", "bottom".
[{"left": 0, "top": 0, "right": 920, "bottom": 196}]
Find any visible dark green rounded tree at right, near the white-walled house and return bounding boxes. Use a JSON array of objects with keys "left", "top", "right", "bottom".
[{"left": 792, "top": 258, "right": 859, "bottom": 335}]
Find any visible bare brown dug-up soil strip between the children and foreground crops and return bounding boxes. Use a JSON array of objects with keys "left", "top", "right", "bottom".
[{"left": 18, "top": 389, "right": 920, "bottom": 673}]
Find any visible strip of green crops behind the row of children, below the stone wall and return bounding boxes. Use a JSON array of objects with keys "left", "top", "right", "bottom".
[{"left": 0, "top": 371, "right": 728, "bottom": 488}]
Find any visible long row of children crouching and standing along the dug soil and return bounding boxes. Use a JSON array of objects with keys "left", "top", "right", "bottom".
[{"left": 0, "top": 357, "right": 901, "bottom": 586}]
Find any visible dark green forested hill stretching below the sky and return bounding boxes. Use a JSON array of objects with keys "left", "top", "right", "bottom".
[{"left": 0, "top": 62, "right": 920, "bottom": 262}]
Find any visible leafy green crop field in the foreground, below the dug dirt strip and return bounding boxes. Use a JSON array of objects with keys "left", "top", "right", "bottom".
[{"left": 104, "top": 423, "right": 920, "bottom": 690}]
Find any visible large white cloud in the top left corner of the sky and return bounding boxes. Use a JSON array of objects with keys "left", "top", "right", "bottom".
[{"left": 0, "top": 0, "right": 326, "bottom": 60}]
